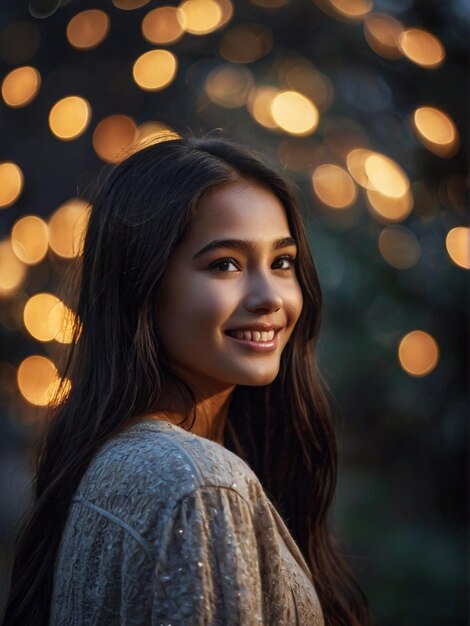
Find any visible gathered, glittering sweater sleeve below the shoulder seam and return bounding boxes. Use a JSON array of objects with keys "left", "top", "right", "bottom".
[{"left": 151, "top": 486, "right": 263, "bottom": 626}]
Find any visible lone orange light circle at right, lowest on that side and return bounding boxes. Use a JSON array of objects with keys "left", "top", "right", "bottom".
[{"left": 398, "top": 330, "right": 439, "bottom": 377}]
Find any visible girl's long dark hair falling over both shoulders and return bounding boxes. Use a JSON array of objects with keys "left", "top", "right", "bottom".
[{"left": 4, "top": 137, "right": 369, "bottom": 626}]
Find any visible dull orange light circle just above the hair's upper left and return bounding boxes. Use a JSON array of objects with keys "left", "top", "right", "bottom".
[{"left": 93, "top": 115, "right": 138, "bottom": 163}]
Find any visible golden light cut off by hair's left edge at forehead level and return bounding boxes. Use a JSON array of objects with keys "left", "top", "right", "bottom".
[{"left": 49, "top": 198, "right": 90, "bottom": 259}]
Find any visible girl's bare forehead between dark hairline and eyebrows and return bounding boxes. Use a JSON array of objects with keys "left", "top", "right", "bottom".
[{"left": 188, "top": 180, "right": 290, "bottom": 239}]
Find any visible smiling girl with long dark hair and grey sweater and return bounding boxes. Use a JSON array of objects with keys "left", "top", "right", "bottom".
[{"left": 4, "top": 138, "right": 369, "bottom": 626}]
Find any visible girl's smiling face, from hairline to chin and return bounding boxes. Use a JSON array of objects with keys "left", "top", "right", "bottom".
[{"left": 157, "top": 180, "right": 302, "bottom": 392}]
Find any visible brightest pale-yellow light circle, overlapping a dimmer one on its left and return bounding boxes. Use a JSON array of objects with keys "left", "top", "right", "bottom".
[{"left": 271, "top": 90, "right": 320, "bottom": 136}]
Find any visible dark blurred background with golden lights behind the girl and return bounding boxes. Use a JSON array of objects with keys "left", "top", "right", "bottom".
[{"left": 0, "top": 0, "right": 470, "bottom": 626}]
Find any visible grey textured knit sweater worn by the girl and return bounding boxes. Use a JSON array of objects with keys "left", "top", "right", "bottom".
[{"left": 49, "top": 419, "right": 324, "bottom": 626}]
